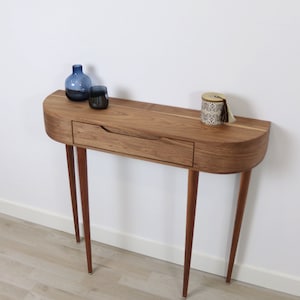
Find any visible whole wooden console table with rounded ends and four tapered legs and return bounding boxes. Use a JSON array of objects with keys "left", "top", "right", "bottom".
[{"left": 43, "top": 90, "right": 271, "bottom": 297}]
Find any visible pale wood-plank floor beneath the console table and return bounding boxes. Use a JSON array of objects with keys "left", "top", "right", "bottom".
[{"left": 0, "top": 214, "right": 299, "bottom": 300}]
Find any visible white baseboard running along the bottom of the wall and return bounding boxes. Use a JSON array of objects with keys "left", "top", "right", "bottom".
[{"left": 0, "top": 198, "right": 300, "bottom": 296}]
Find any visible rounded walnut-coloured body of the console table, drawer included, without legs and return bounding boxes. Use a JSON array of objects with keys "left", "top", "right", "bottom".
[{"left": 43, "top": 90, "right": 271, "bottom": 173}]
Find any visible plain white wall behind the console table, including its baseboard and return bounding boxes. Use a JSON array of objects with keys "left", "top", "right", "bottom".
[{"left": 0, "top": 0, "right": 300, "bottom": 295}]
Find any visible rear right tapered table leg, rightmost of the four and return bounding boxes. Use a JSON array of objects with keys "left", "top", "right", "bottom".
[{"left": 226, "top": 170, "right": 251, "bottom": 282}]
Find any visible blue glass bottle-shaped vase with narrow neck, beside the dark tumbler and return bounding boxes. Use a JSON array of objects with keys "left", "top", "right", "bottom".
[{"left": 65, "top": 65, "right": 92, "bottom": 101}]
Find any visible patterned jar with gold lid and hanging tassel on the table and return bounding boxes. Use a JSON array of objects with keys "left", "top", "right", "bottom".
[{"left": 200, "top": 93, "right": 235, "bottom": 125}]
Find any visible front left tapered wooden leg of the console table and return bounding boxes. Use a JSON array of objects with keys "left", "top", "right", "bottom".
[{"left": 77, "top": 147, "right": 93, "bottom": 273}]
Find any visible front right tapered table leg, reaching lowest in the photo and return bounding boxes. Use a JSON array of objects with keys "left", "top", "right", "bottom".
[{"left": 182, "top": 170, "right": 199, "bottom": 297}]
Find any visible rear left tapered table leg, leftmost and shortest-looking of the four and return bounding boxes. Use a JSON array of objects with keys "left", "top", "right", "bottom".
[{"left": 66, "top": 145, "right": 80, "bottom": 243}]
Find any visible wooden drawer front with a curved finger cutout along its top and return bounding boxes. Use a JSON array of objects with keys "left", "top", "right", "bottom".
[{"left": 73, "top": 122, "right": 194, "bottom": 167}]
